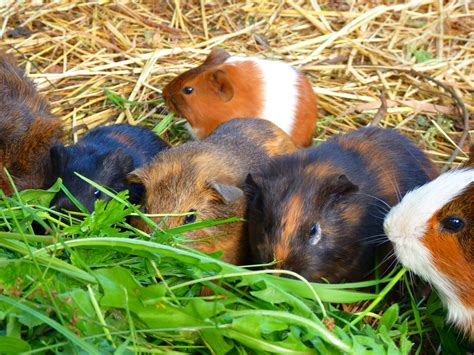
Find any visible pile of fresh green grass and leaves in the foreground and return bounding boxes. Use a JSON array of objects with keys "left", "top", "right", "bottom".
[{"left": 0, "top": 181, "right": 472, "bottom": 354}]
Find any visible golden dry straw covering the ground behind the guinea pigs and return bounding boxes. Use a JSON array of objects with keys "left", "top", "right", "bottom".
[{"left": 0, "top": 0, "right": 474, "bottom": 169}]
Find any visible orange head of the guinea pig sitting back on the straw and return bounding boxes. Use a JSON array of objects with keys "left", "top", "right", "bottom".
[{"left": 163, "top": 49, "right": 235, "bottom": 138}]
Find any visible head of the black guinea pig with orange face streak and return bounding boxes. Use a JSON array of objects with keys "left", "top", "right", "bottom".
[{"left": 246, "top": 169, "right": 360, "bottom": 282}]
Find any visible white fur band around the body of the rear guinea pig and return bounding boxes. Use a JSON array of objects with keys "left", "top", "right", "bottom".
[{"left": 226, "top": 57, "right": 299, "bottom": 135}]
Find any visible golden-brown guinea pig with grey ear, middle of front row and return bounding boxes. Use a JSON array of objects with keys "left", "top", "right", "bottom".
[{"left": 129, "top": 119, "right": 295, "bottom": 264}]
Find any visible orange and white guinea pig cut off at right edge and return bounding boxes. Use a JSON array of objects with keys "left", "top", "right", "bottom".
[{"left": 384, "top": 148, "right": 474, "bottom": 340}]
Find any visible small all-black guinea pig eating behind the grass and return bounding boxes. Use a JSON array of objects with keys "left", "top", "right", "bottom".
[{"left": 51, "top": 124, "right": 168, "bottom": 211}]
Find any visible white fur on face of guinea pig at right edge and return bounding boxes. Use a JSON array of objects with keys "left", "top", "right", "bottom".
[{"left": 384, "top": 169, "right": 474, "bottom": 326}]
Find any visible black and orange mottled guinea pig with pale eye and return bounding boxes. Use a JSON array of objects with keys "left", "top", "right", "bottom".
[{"left": 246, "top": 128, "right": 436, "bottom": 282}]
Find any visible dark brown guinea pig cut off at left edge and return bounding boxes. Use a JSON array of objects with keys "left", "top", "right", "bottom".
[{"left": 0, "top": 51, "right": 63, "bottom": 195}]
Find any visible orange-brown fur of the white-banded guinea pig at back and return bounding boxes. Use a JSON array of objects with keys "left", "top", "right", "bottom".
[{"left": 163, "top": 49, "right": 317, "bottom": 147}]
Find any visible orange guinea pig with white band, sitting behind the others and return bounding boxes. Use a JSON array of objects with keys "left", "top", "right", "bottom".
[{"left": 163, "top": 48, "right": 317, "bottom": 147}]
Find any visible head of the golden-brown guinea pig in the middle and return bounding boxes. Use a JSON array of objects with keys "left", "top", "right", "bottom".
[{"left": 129, "top": 143, "right": 250, "bottom": 264}]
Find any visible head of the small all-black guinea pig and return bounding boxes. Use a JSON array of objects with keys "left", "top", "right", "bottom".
[{"left": 50, "top": 145, "right": 136, "bottom": 211}]
